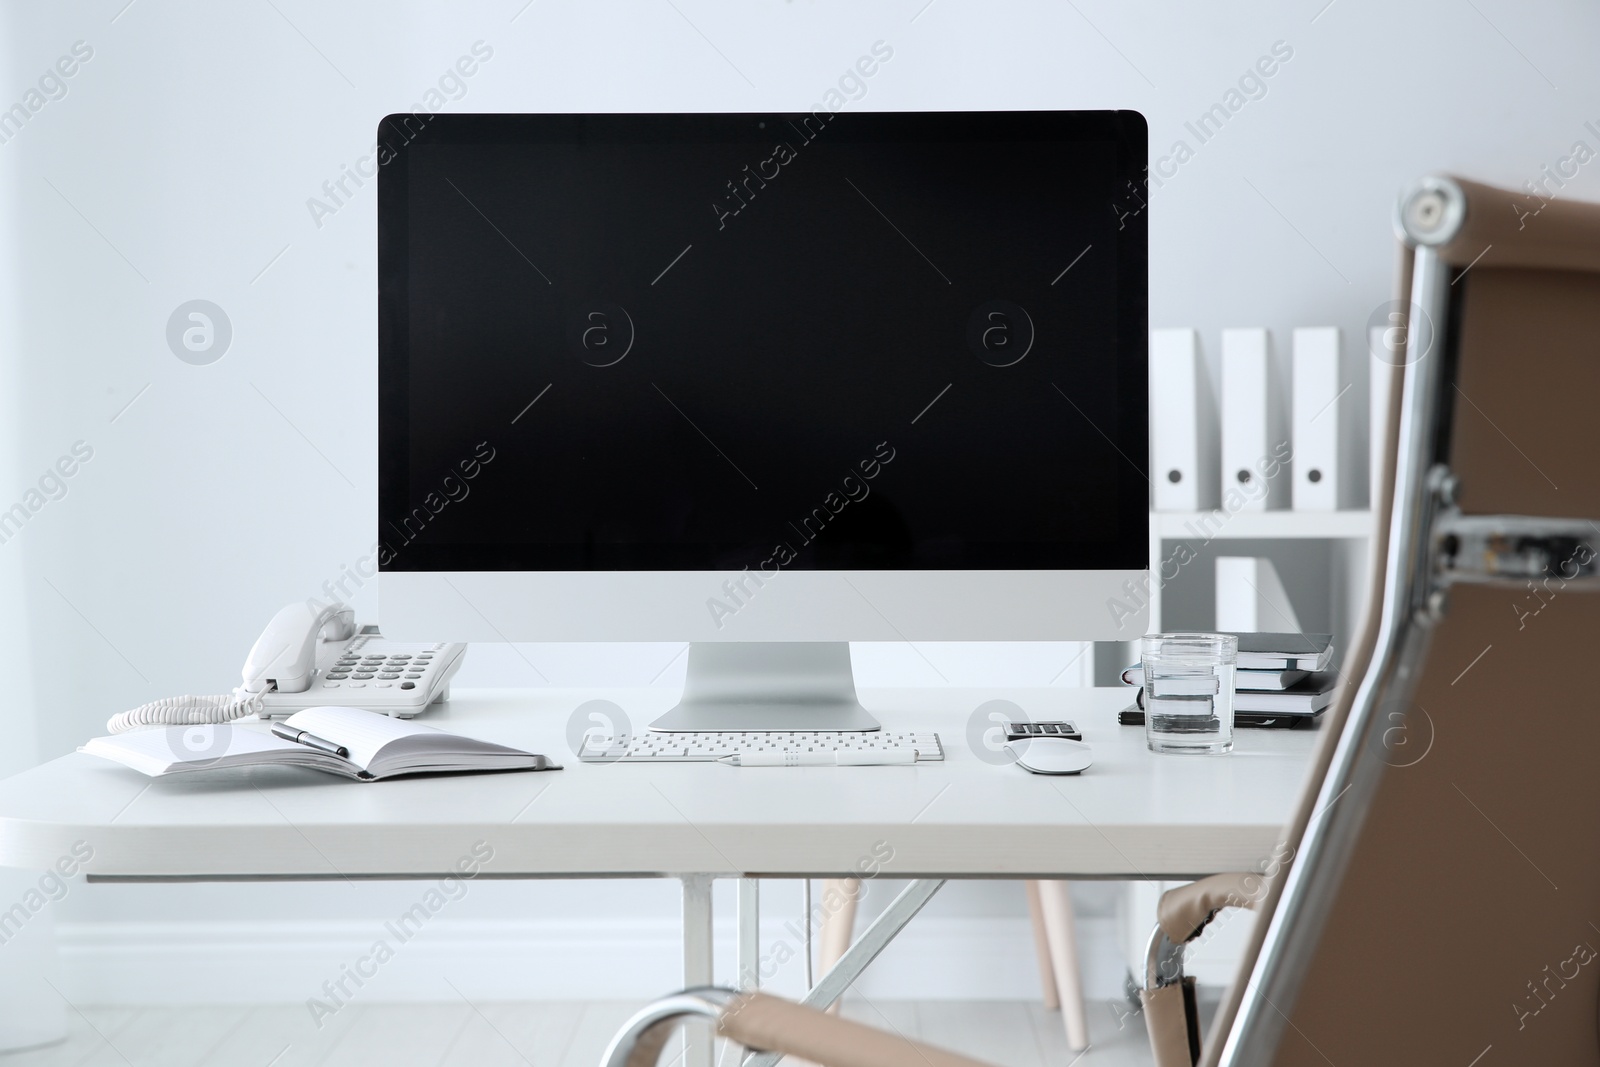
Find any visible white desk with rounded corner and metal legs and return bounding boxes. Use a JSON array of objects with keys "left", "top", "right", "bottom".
[{"left": 0, "top": 688, "right": 1318, "bottom": 1062}]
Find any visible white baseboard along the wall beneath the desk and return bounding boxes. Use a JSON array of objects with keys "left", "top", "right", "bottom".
[{"left": 58, "top": 917, "right": 1125, "bottom": 1005}]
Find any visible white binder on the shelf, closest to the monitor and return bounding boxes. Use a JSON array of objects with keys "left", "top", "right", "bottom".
[{"left": 1150, "top": 330, "right": 1218, "bottom": 512}]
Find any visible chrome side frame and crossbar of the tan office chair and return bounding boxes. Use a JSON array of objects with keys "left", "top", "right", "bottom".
[{"left": 1208, "top": 178, "right": 1600, "bottom": 1067}]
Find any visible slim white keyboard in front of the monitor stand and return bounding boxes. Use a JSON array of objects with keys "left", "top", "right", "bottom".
[{"left": 578, "top": 729, "right": 944, "bottom": 763}]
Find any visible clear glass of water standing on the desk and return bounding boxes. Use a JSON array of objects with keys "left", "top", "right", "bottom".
[{"left": 1139, "top": 633, "right": 1238, "bottom": 752}]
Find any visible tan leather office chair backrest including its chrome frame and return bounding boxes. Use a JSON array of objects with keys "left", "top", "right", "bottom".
[{"left": 1203, "top": 179, "right": 1600, "bottom": 1067}]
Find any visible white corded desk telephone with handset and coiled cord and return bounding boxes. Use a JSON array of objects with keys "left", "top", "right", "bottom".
[{"left": 106, "top": 601, "right": 467, "bottom": 734}]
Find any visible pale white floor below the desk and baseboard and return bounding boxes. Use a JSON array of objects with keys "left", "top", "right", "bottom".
[{"left": 0, "top": 995, "right": 1152, "bottom": 1067}]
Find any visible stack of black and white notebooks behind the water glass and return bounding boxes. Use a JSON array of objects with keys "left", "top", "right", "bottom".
[{"left": 1118, "top": 633, "right": 1339, "bottom": 726}]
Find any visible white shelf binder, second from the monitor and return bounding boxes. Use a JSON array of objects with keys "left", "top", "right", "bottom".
[{"left": 1222, "top": 330, "right": 1293, "bottom": 512}]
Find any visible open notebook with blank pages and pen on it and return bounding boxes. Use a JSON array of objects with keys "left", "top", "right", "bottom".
[{"left": 80, "top": 707, "right": 560, "bottom": 781}]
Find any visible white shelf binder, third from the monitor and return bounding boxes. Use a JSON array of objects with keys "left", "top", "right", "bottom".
[{"left": 1293, "top": 326, "right": 1357, "bottom": 512}]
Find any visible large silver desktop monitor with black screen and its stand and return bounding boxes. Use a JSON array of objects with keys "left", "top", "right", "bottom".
[{"left": 378, "top": 109, "right": 1149, "bottom": 729}]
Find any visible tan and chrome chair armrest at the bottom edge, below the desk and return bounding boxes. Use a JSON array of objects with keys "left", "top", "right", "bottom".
[{"left": 602, "top": 989, "right": 990, "bottom": 1067}]
